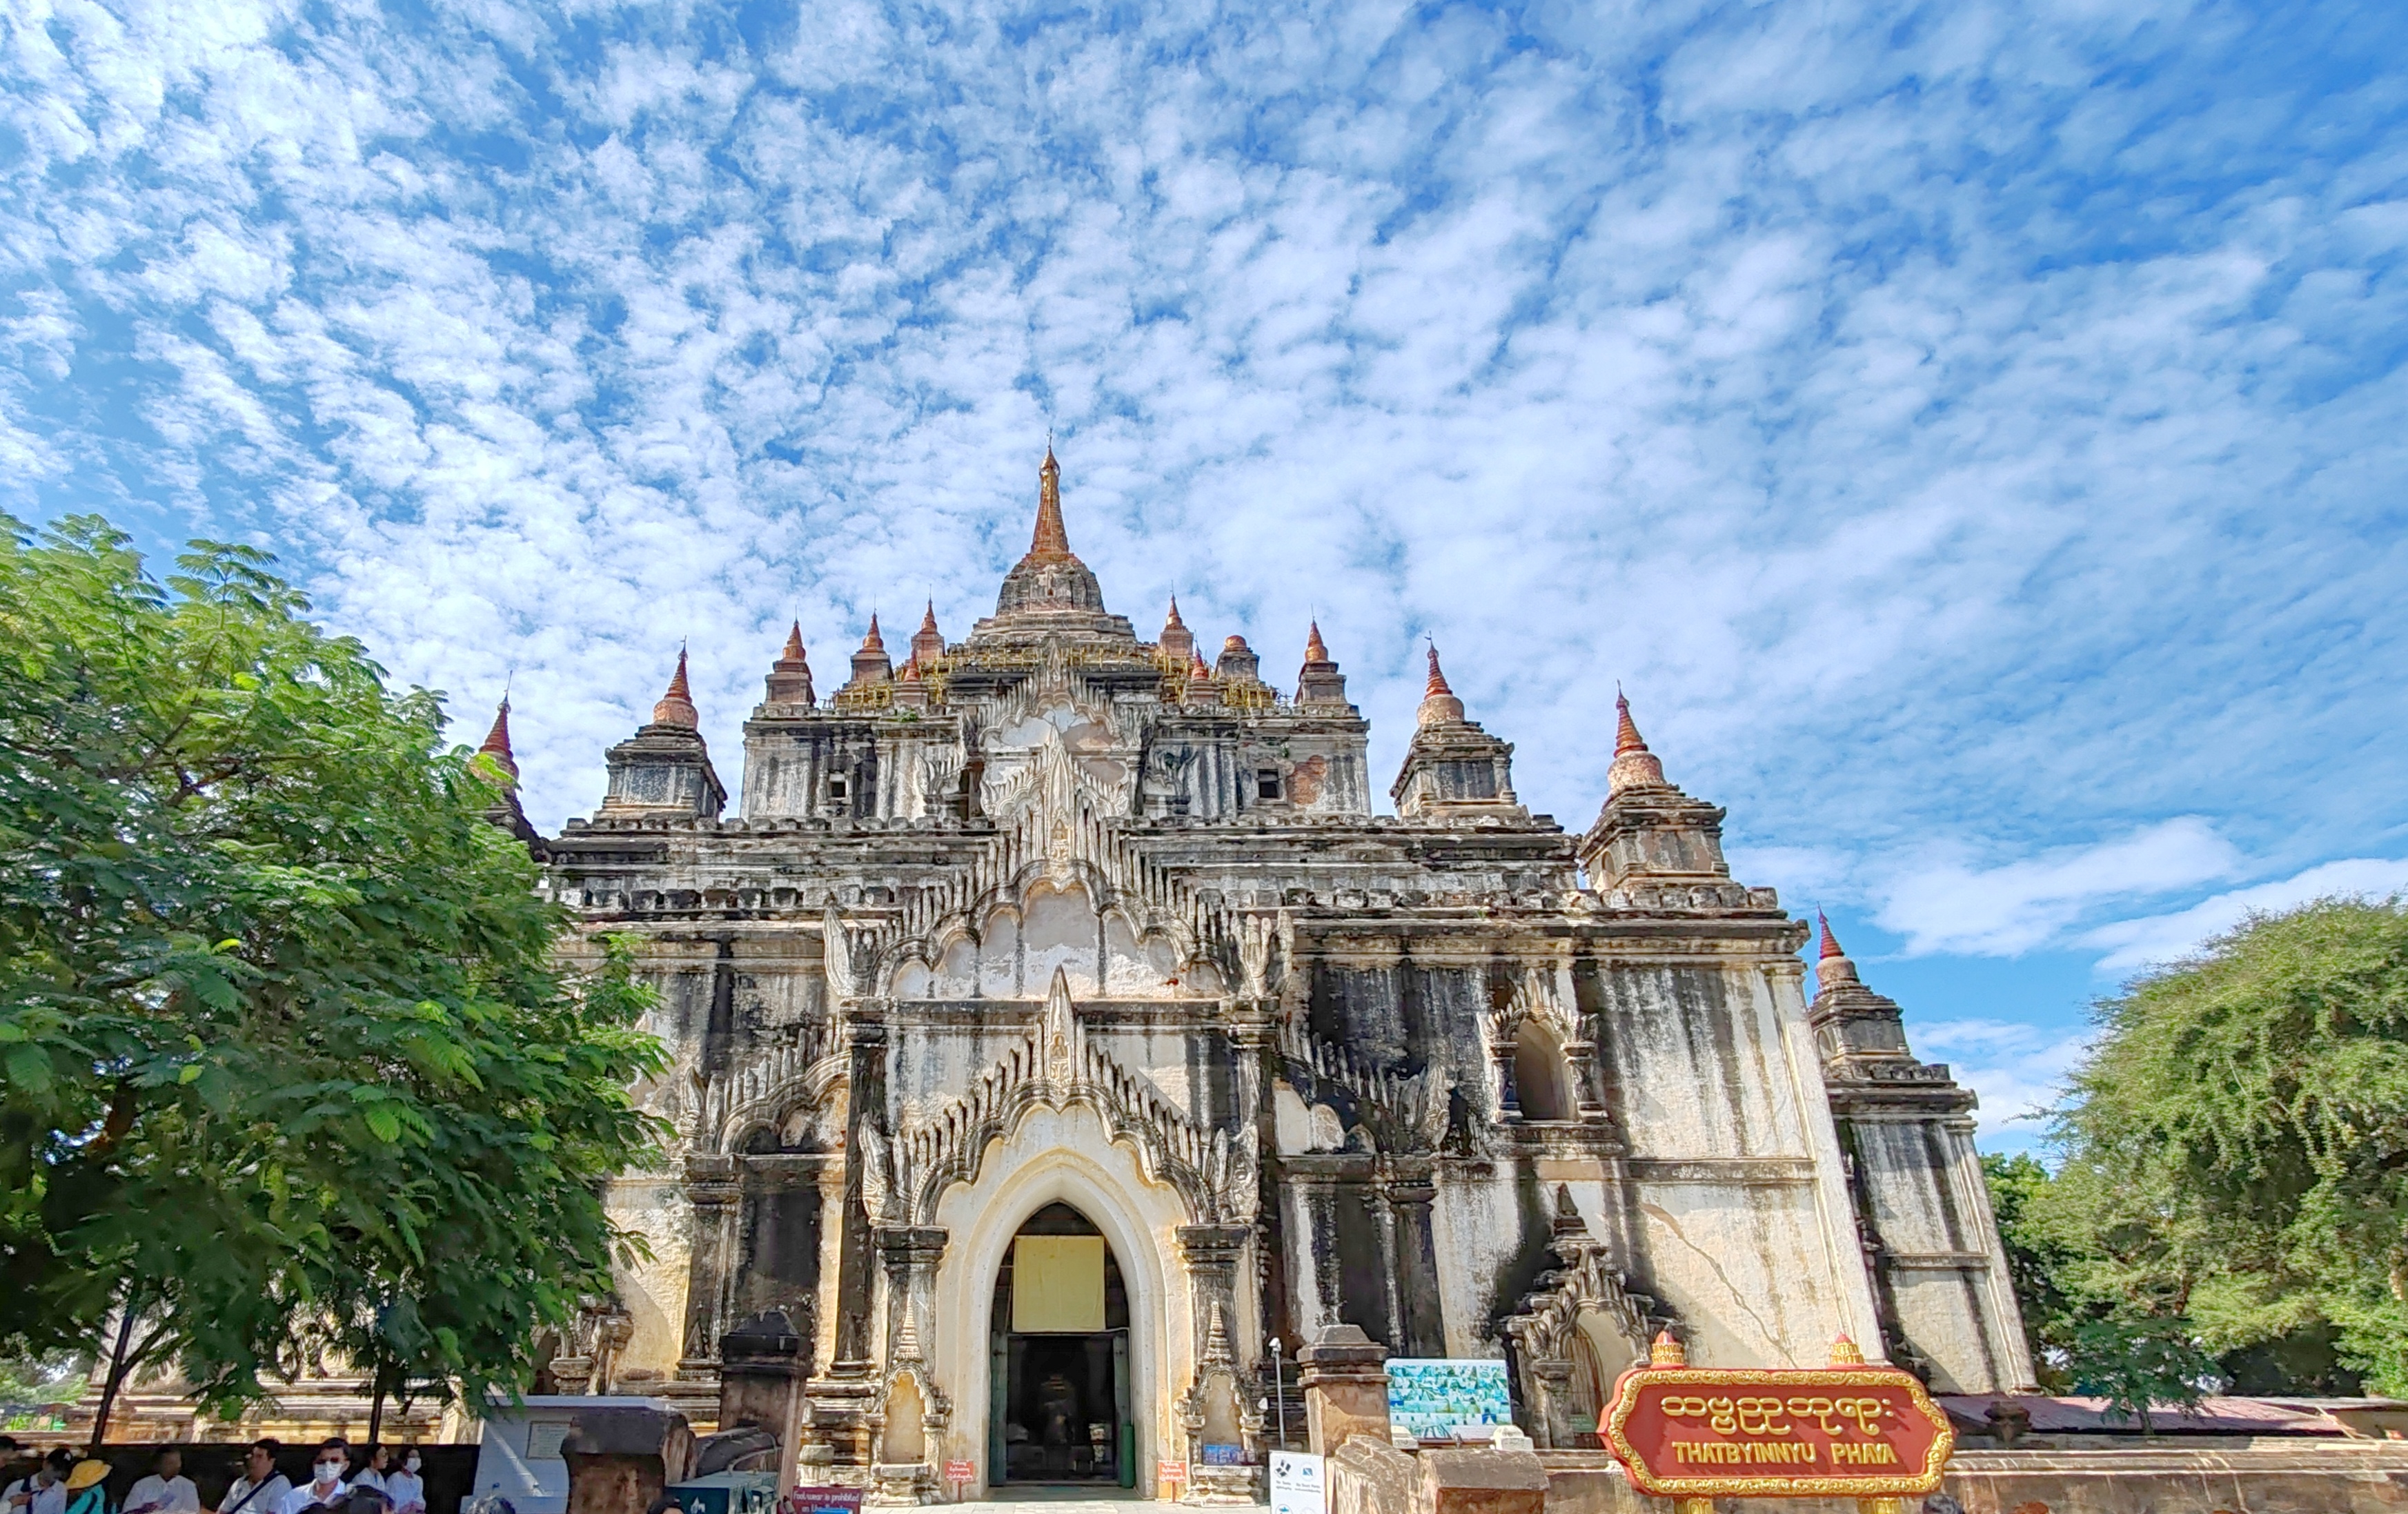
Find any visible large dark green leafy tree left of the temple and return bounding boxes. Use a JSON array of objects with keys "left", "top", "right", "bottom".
[{"left": 0, "top": 515, "right": 662, "bottom": 1434}]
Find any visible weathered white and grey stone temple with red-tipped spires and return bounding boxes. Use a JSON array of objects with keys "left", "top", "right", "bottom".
[{"left": 522, "top": 448, "right": 2033, "bottom": 1502}]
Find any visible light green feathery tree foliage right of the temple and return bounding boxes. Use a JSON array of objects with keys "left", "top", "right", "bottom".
[{"left": 1991, "top": 901, "right": 2408, "bottom": 1394}]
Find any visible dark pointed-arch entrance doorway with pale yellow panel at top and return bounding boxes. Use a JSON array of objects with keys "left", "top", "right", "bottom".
[{"left": 987, "top": 1203, "right": 1136, "bottom": 1488}]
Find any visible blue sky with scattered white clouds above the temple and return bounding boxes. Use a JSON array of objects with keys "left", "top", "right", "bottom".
[{"left": 0, "top": 0, "right": 2408, "bottom": 1146}]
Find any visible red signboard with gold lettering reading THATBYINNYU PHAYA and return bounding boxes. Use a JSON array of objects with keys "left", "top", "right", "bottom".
[{"left": 1597, "top": 1365, "right": 1955, "bottom": 1497}]
